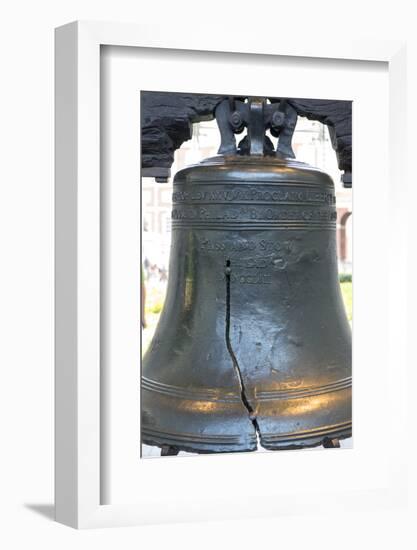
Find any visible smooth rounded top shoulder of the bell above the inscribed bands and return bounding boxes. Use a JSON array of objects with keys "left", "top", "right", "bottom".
[{"left": 173, "top": 154, "right": 335, "bottom": 189}]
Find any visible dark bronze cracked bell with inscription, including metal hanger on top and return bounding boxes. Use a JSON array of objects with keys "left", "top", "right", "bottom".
[{"left": 141, "top": 98, "right": 352, "bottom": 454}]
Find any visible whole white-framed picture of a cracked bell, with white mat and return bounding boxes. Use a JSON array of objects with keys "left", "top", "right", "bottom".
[{"left": 56, "top": 22, "right": 408, "bottom": 528}]
